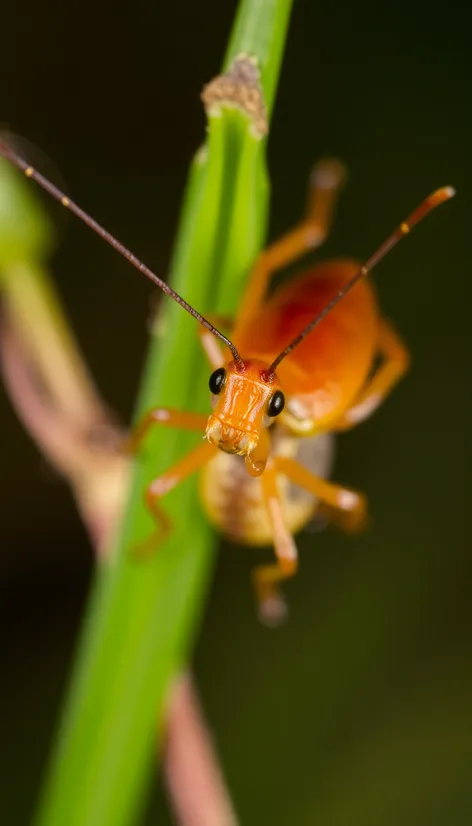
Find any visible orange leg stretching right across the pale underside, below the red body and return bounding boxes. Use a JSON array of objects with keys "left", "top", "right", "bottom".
[{"left": 273, "top": 456, "right": 367, "bottom": 532}]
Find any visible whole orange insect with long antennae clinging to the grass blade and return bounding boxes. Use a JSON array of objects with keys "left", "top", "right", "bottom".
[{"left": 0, "top": 142, "right": 454, "bottom": 623}]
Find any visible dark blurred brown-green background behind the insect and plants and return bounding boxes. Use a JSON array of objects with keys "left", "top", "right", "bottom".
[{"left": 0, "top": 0, "right": 472, "bottom": 826}]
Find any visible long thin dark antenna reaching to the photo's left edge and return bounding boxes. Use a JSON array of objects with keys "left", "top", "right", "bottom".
[{"left": 0, "top": 140, "right": 244, "bottom": 370}]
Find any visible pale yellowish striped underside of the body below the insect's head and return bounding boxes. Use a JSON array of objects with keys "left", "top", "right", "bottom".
[{"left": 199, "top": 426, "right": 334, "bottom": 545}]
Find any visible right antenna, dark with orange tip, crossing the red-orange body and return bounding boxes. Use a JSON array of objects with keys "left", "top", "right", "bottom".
[{"left": 266, "top": 186, "right": 456, "bottom": 375}]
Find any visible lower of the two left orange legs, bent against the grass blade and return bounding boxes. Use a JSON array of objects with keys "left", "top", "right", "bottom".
[{"left": 138, "top": 441, "right": 218, "bottom": 555}]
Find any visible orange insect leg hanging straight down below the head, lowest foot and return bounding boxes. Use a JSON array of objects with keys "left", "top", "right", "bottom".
[{"left": 253, "top": 467, "right": 298, "bottom": 625}]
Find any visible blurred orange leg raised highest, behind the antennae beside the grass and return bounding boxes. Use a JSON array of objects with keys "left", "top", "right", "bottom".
[{"left": 233, "top": 159, "right": 346, "bottom": 330}]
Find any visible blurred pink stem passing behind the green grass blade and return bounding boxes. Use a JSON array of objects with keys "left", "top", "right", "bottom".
[{"left": 0, "top": 306, "right": 237, "bottom": 826}]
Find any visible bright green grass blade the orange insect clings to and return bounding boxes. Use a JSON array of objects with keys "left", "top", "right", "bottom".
[{"left": 23, "top": 0, "right": 291, "bottom": 826}]
